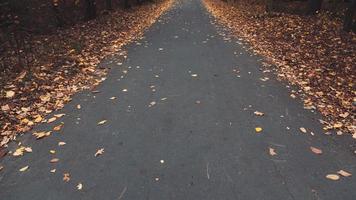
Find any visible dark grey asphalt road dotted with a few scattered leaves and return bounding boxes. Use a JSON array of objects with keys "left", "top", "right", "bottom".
[{"left": 0, "top": 0, "right": 356, "bottom": 200}]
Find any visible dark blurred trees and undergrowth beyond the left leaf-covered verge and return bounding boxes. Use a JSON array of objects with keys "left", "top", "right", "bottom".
[{"left": 0, "top": 0, "right": 152, "bottom": 75}]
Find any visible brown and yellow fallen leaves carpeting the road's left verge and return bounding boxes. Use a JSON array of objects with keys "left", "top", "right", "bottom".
[{"left": 0, "top": 0, "right": 172, "bottom": 147}]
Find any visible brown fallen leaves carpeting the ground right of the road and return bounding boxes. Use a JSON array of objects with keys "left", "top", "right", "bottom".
[{"left": 204, "top": 0, "right": 356, "bottom": 139}]
